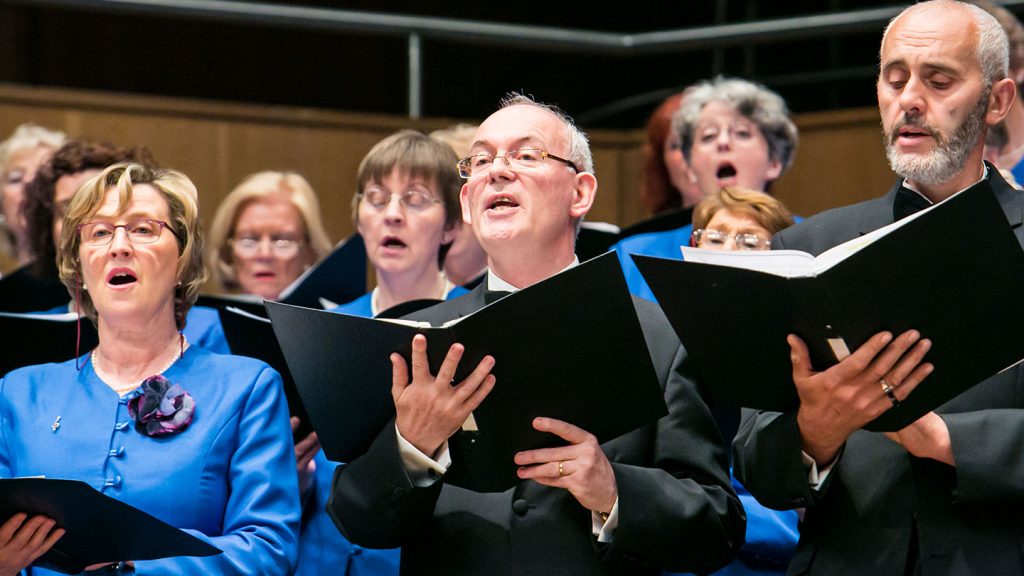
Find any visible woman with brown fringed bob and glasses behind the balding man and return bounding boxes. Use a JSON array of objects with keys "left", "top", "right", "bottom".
[{"left": 296, "top": 130, "right": 467, "bottom": 576}]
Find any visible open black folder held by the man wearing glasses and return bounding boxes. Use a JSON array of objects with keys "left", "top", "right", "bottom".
[{"left": 266, "top": 253, "right": 668, "bottom": 491}]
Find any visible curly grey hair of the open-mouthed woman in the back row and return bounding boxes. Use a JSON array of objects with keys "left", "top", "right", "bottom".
[{"left": 672, "top": 76, "right": 799, "bottom": 171}]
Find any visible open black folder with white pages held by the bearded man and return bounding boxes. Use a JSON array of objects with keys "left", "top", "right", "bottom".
[{"left": 633, "top": 180, "right": 1024, "bottom": 431}]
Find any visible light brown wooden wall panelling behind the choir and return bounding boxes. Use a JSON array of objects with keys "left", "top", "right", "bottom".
[{"left": 0, "top": 85, "right": 893, "bottom": 251}]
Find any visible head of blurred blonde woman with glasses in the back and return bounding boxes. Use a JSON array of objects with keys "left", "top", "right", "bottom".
[{"left": 209, "top": 171, "right": 331, "bottom": 300}]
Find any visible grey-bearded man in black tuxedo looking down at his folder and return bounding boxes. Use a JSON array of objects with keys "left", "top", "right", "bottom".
[{"left": 733, "top": 0, "right": 1024, "bottom": 575}]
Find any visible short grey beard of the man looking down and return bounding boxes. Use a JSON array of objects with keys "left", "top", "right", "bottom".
[{"left": 886, "top": 90, "right": 989, "bottom": 186}]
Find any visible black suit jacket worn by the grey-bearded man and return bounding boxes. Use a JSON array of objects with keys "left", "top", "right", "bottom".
[{"left": 733, "top": 167, "right": 1024, "bottom": 576}]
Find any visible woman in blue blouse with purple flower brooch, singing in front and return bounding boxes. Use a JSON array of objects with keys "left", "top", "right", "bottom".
[{"left": 0, "top": 164, "right": 300, "bottom": 576}]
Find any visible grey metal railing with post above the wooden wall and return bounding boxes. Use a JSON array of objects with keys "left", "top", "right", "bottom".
[{"left": 6, "top": 0, "right": 1024, "bottom": 118}]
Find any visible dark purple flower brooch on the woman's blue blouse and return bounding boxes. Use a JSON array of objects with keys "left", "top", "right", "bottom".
[{"left": 128, "top": 374, "right": 196, "bottom": 436}]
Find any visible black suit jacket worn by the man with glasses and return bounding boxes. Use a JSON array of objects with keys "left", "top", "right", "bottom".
[{"left": 328, "top": 283, "right": 745, "bottom": 576}]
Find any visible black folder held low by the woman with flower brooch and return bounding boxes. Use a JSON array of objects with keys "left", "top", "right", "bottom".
[{"left": 0, "top": 478, "right": 221, "bottom": 574}]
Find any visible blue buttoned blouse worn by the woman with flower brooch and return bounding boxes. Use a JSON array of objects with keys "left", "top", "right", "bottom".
[{"left": 0, "top": 346, "right": 301, "bottom": 576}]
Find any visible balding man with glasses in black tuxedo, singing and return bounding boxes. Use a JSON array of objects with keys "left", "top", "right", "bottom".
[{"left": 328, "top": 96, "right": 744, "bottom": 575}]
